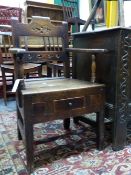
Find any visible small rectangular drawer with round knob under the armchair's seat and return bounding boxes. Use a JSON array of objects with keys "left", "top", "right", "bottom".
[{"left": 54, "top": 96, "right": 85, "bottom": 112}]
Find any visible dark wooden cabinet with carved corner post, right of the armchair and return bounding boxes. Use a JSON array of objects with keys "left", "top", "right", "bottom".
[{"left": 73, "top": 27, "right": 131, "bottom": 150}]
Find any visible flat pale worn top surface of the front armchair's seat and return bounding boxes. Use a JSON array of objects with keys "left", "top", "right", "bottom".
[{"left": 22, "top": 78, "right": 104, "bottom": 96}]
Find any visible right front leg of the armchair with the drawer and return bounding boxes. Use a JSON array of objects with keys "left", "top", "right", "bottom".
[{"left": 96, "top": 110, "right": 104, "bottom": 150}]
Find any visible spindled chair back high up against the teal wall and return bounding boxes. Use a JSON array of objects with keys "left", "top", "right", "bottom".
[{"left": 62, "top": 0, "right": 79, "bottom": 20}]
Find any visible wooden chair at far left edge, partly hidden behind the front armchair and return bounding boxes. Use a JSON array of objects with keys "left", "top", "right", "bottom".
[{"left": 0, "top": 25, "right": 42, "bottom": 105}]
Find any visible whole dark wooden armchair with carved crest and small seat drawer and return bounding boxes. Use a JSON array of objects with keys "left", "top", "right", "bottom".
[{"left": 10, "top": 17, "right": 104, "bottom": 172}]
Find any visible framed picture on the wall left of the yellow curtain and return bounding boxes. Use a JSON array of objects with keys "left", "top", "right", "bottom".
[{"left": 90, "top": 0, "right": 105, "bottom": 27}]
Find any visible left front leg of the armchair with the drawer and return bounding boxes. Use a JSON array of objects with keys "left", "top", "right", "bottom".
[{"left": 24, "top": 121, "right": 34, "bottom": 173}]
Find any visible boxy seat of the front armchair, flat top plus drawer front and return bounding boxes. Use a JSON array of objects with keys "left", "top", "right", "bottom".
[{"left": 20, "top": 78, "right": 104, "bottom": 123}]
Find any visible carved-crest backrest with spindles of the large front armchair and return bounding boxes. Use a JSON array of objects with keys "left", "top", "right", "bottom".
[{"left": 12, "top": 16, "right": 69, "bottom": 78}]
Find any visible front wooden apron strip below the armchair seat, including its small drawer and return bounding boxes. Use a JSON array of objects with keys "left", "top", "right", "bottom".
[{"left": 32, "top": 94, "right": 104, "bottom": 118}]
